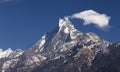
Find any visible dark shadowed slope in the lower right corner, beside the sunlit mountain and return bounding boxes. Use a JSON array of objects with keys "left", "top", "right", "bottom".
[{"left": 88, "top": 43, "right": 120, "bottom": 72}]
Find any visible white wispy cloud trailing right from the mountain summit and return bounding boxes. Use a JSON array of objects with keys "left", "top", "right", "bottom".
[{"left": 69, "top": 10, "right": 110, "bottom": 29}]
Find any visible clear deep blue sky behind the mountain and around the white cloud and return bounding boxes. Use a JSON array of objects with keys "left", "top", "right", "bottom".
[{"left": 0, "top": 0, "right": 120, "bottom": 50}]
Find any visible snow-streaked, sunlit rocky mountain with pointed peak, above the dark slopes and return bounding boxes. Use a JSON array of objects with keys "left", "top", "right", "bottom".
[{"left": 0, "top": 17, "right": 114, "bottom": 72}]
